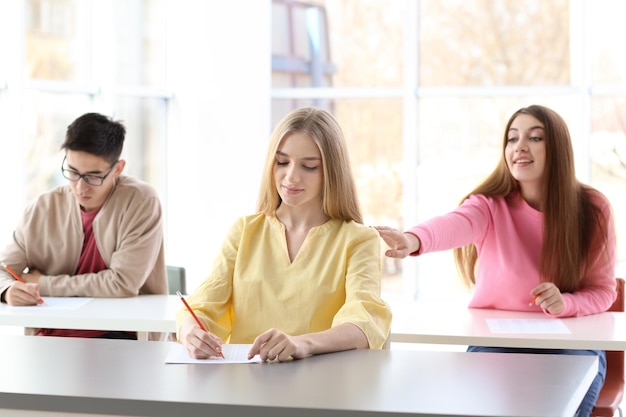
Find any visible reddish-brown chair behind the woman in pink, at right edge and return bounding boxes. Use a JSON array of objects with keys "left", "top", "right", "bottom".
[{"left": 591, "top": 278, "right": 624, "bottom": 417}]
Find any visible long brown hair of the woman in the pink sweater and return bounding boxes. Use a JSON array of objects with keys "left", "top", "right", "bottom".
[{"left": 454, "top": 105, "right": 608, "bottom": 292}]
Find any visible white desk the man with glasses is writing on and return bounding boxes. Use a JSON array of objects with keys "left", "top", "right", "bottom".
[{"left": 0, "top": 295, "right": 178, "bottom": 333}]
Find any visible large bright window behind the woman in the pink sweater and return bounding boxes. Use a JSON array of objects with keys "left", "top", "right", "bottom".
[{"left": 272, "top": 0, "right": 626, "bottom": 300}]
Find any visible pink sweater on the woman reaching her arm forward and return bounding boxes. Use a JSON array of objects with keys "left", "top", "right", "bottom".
[{"left": 407, "top": 192, "right": 616, "bottom": 317}]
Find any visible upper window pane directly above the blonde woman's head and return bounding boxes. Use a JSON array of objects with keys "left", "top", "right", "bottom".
[{"left": 272, "top": 0, "right": 406, "bottom": 87}]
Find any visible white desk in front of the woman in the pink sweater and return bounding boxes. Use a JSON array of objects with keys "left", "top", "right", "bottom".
[{"left": 391, "top": 302, "right": 626, "bottom": 350}]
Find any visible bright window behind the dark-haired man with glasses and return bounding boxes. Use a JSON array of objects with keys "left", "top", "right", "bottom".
[{"left": 19, "top": 0, "right": 169, "bottom": 199}]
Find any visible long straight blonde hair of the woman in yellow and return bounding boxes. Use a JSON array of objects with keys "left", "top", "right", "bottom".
[{"left": 257, "top": 107, "right": 363, "bottom": 223}]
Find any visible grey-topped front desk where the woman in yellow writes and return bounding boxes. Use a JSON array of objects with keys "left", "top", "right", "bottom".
[{"left": 0, "top": 335, "right": 598, "bottom": 417}]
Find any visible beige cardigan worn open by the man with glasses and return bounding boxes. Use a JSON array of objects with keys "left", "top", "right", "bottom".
[{"left": 0, "top": 176, "right": 168, "bottom": 297}]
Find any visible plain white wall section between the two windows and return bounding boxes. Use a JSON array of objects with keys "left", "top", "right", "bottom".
[{"left": 163, "top": 0, "right": 271, "bottom": 291}]
